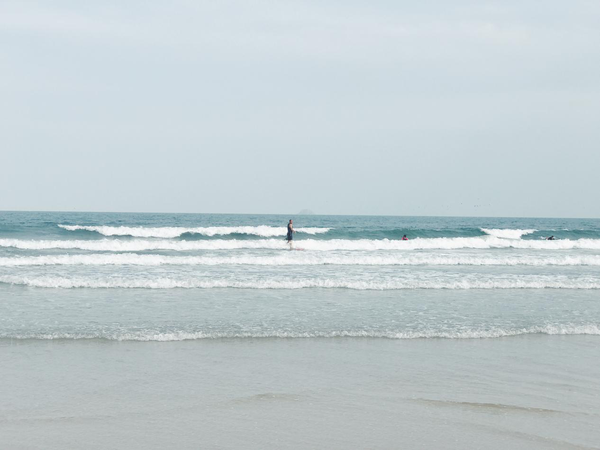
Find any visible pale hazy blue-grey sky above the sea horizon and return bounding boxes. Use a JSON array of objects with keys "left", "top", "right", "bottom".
[{"left": 0, "top": 0, "right": 600, "bottom": 217}]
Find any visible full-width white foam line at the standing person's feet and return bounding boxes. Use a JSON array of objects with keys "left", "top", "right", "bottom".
[{"left": 0, "top": 236, "right": 600, "bottom": 252}]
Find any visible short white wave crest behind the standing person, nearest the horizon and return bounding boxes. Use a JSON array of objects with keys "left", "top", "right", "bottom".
[{"left": 58, "top": 225, "right": 330, "bottom": 239}]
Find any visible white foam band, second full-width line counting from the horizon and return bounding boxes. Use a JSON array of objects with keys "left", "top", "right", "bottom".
[{"left": 0, "top": 252, "right": 600, "bottom": 267}]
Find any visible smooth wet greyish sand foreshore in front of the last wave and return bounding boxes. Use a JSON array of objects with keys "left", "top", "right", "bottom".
[{"left": 0, "top": 335, "right": 600, "bottom": 450}]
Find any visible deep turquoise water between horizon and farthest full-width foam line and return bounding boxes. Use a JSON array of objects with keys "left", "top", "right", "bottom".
[{"left": 0, "top": 211, "right": 600, "bottom": 240}]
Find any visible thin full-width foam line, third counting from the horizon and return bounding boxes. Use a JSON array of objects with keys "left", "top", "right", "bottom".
[{"left": 0, "top": 275, "right": 600, "bottom": 290}]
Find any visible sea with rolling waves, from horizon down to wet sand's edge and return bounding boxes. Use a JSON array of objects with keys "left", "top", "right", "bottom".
[{"left": 0, "top": 212, "right": 600, "bottom": 340}]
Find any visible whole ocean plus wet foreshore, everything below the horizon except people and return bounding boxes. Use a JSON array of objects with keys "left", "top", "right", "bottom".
[{"left": 0, "top": 212, "right": 600, "bottom": 449}]
